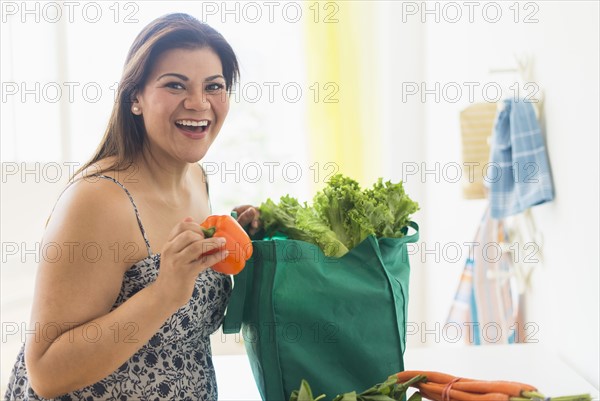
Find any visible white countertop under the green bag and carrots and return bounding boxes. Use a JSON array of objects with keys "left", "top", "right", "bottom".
[{"left": 213, "top": 344, "right": 600, "bottom": 401}]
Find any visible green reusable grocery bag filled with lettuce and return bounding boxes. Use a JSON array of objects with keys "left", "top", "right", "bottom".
[{"left": 223, "top": 222, "right": 419, "bottom": 401}]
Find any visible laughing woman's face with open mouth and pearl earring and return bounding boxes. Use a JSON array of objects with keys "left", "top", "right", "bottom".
[{"left": 132, "top": 47, "right": 229, "bottom": 163}]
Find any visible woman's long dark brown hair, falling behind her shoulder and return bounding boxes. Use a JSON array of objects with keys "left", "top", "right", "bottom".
[{"left": 71, "top": 13, "right": 239, "bottom": 180}]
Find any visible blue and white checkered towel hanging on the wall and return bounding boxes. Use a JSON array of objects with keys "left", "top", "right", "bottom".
[{"left": 485, "top": 99, "right": 554, "bottom": 219}]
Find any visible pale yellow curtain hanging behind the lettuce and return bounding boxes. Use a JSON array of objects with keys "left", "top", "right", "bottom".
[{"left": 304, "top": 1, "right": 381, "bottom": 189}]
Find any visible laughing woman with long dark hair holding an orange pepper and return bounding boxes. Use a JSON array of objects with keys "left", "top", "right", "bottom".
[{"left": 6, "top": 14, "right": 258, "bottom": 400}]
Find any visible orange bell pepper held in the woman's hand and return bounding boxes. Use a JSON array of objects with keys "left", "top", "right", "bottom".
[{"left": 200, "top": 215, "right": 253, "bottom": 275}]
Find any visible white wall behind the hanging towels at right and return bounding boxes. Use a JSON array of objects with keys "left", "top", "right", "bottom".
[{"left": 394, "top": 1, "right": 599, "bottom": 387}]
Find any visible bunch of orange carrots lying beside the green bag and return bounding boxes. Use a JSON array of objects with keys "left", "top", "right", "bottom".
[{"left": 390, "top": 370, "right": 592, "bottom": 401}]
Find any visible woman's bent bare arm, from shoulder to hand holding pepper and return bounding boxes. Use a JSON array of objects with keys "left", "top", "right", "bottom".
[{"left": 25, "top": 182, "right": 224, "bottom": 398}]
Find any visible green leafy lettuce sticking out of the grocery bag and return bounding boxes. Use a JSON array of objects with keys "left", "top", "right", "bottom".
[{"left": 259, "top": 174, "right": 419, "bottom": 257}]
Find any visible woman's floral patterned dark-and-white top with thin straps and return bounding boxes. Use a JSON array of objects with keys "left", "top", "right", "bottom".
[{"left": 5, "top": 175, "right": 232, "bottom": 401}]
